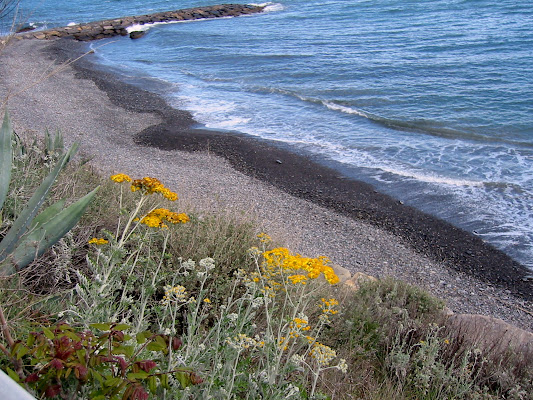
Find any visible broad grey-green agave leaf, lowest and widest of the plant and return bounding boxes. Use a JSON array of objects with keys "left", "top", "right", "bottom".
[{"left": 11, "top": 187, "right": 99, "bottom": 272}]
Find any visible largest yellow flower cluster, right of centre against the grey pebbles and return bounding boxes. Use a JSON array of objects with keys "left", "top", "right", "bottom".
[{"left": 263, "top": 247, "right": 339, "bottom": 285}]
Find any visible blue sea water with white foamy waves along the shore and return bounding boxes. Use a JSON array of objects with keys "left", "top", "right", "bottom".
[{"left": 12, "top": 0, "right": 533, "bottom": 268}]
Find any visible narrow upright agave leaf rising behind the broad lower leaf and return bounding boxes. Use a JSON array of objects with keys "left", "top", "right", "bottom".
[{"left": 0, "top": 144, "right": 78, "bottom": 262}]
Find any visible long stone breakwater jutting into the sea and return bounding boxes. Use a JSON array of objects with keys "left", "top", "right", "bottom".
[{"left": 10, "top": 4, "right": 264, "bottom": 41}]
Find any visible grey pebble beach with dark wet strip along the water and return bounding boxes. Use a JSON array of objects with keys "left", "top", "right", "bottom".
[{"left": 0, "top": 39, "right": 533, "bottom": 331}]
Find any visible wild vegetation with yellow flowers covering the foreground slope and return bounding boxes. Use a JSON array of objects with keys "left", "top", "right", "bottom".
[{"left": 0, "top": 120, "right": 533, "bottom": 399}]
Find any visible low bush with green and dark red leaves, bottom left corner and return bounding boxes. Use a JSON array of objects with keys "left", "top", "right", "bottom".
[{"left": 7, "top": 323, "right": 202, "bottom": 400}]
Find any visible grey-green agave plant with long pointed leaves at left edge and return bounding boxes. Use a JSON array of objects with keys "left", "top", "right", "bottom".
[{"left": 0, "top": 112, "right": 98, "bottom": 275}]
